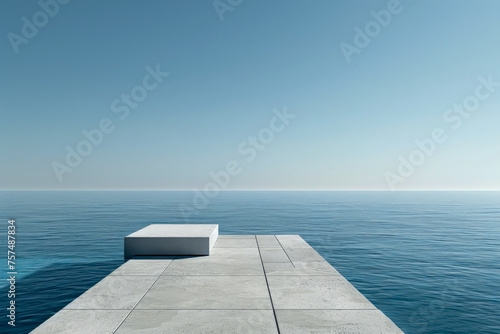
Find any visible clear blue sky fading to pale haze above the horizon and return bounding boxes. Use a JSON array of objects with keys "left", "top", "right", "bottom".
[{"left": 0, "top": 0, "right": 500, "bottom": 190}]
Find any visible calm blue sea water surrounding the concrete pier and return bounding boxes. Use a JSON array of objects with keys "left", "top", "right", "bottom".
[{"left": 0, "top": 191, "right": 500, "bottom": 334}]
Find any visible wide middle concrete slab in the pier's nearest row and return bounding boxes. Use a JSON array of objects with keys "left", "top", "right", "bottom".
[{"left": 116, "top": 310, "right": 278, "bottom": 334}]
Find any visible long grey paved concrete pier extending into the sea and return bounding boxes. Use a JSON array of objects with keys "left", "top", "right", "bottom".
[{"left": 32, "top": 235, "right": 403, "bottom": 334}]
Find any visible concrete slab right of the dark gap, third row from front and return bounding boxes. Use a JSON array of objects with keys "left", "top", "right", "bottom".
[{"left": 264, "top": 261, "right": 340, "bottom": 276}]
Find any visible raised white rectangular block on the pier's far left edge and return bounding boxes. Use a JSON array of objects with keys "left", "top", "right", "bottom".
[{"left": 124, "top": 224, "right": 219, "bottom": 259}]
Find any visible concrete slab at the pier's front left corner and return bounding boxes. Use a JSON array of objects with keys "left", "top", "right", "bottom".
[{"left": 31, "top": 310, "right": 130, "bottom": 334}]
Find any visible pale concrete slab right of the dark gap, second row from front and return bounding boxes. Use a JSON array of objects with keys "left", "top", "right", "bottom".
[{"left": 267, "top": 275, "right": 375, "bottom": 310}]
